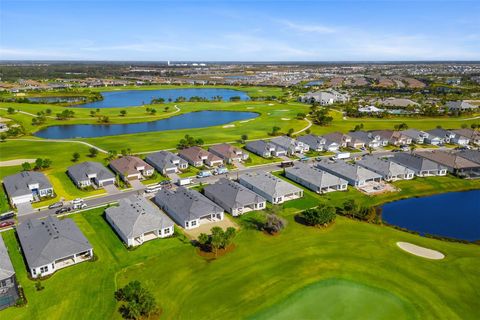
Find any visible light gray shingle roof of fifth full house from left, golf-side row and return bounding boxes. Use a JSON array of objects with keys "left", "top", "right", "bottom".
[{"left": 240, "top": 172, "right": 302, "bottom": 198}]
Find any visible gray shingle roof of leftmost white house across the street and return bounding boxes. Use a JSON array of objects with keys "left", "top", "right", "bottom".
[{"left": 3, "top": 171, "right": 52, "bottom": 198}]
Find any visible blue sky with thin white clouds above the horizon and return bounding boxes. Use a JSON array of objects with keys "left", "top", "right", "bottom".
[{"left": 0, "top": 0, "right": 480, "bottom": 61}]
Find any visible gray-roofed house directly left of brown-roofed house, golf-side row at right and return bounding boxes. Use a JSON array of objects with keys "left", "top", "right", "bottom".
[{"left": 390, "top": 152, "right": 447, "bottom": 177}]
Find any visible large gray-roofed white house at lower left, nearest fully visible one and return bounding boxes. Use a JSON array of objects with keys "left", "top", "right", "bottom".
[{"left": 17, "top": 216, "right": 93, "bottom": 278}]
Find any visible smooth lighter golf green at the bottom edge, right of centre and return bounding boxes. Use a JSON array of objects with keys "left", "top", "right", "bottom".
[{"left": 252, "top": 279, "right": 415, "bottom": 320}]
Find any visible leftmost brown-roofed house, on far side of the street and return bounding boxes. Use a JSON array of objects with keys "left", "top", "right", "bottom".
[{"left": 110, "top": 156, "right": 154, "bottom": 181}]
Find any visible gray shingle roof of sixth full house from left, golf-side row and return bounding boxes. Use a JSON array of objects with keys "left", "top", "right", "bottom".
[{"left": 285, "top": 163, "right": 347, "bottom": 188}]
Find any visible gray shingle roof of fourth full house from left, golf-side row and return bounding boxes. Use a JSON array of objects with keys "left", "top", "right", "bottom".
[{"left": 201, "top": 178, "right": 266, "bottom": 209}]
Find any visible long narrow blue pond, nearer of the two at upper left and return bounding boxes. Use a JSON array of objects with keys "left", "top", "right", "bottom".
[{"left": 35, "top": 111, "right": 258, "bottom": 139}]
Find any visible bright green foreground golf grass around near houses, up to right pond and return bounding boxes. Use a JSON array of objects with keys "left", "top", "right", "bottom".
[{"left": 0, "top": 177, "right": 480, "bottom": 319}]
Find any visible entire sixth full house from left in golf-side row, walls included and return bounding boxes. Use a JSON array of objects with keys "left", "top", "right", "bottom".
[{"left": 285, "top": 163, "right": 348, "bottom": 193}]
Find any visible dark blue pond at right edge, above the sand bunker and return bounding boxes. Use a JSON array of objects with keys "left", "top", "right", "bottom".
[{"left": 382, "top": 190, "right": 480, "bottom": 241}]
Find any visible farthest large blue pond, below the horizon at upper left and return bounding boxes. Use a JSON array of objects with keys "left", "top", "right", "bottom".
[{"left": 79, "top": 88, "right": 249, "bottom": 108}]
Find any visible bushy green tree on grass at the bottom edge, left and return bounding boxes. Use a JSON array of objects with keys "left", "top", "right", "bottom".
[{"left": 114, "top": 281, "right": 158, "bottom": 319}]
